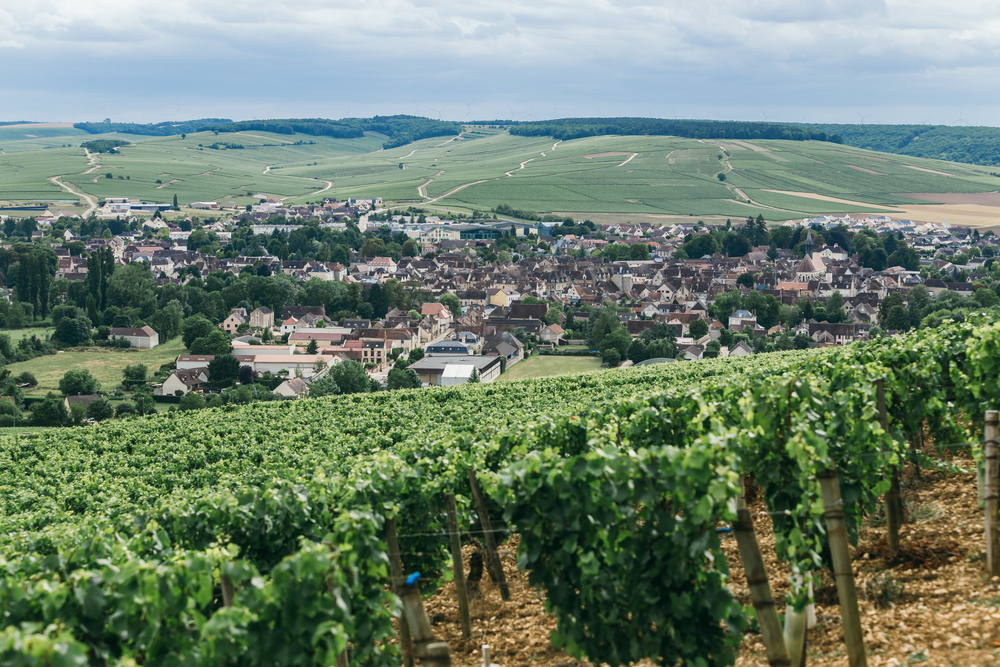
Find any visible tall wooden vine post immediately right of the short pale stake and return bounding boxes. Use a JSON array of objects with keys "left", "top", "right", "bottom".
[{"left": 817, "top": 467, "right": 868, "bottom": 667}]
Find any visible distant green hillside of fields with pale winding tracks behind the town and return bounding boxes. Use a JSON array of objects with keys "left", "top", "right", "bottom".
[{"left": 0, "top": 122, "right": 1000, "bottom": 220}]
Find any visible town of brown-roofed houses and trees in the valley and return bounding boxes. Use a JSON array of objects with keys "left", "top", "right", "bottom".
[{"left": 0, "top": 193, "right": 1000, "bottom": 409}]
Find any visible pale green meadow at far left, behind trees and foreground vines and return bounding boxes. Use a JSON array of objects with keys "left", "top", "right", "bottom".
[{"left": 7, "top": 340, "right": 184, "bottom": 396}]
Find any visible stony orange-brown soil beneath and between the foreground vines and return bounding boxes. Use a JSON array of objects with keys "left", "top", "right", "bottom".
[{"left": 418, "top": 458, "right": 1000, "bottom": 667}]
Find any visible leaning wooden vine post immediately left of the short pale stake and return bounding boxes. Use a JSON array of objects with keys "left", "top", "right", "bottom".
[{"left": 733, "top": 482, "right": 792, "bottom": 667}]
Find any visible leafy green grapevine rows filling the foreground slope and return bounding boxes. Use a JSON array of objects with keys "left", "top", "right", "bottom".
[{"left": 0, "top": 322, "right": 1000, "bottom": 667}]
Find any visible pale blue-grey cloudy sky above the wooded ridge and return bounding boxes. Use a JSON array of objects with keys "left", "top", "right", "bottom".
[{"left": 0, "top": 0, "right": 1000, "bottom": 126}]
